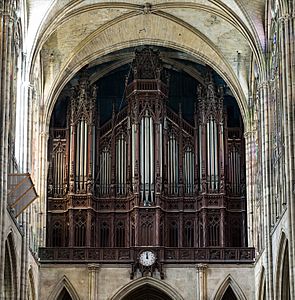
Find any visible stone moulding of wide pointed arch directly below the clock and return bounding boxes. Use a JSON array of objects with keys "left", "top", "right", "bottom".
[{"left": 110, "top": 277, "right": 184, "bottom": 300}]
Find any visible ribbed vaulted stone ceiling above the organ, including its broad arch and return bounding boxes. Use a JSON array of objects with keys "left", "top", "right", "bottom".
[{"left": 28, "top": 0, "right": 265, "bottom": 127}]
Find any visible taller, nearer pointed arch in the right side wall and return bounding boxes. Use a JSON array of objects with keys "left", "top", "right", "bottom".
[{"left": 276, "top": 231, "right": 290, "bottom": 300}]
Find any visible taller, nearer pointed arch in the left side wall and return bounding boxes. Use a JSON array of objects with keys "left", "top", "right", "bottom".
[{"left": 4, "top": 232, "right": 18, "bottom": 299}]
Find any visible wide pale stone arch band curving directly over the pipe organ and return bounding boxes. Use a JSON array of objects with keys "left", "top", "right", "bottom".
[{"left": 38, "top": 9, "right": 249, "bottom": 132}]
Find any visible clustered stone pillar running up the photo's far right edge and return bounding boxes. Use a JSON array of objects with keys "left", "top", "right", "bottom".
[{"left": 279, "top": 13, "right": 295, "bottom": 299}]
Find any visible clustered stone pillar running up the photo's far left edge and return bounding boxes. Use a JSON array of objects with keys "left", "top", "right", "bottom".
[{"left": 0, "top": 0, "right": 18, "bottom": 299}]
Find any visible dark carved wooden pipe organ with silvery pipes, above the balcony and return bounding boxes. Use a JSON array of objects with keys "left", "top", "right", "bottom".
[{"left": 47, "top": 48, "right": 246, "bottom": 248}]
